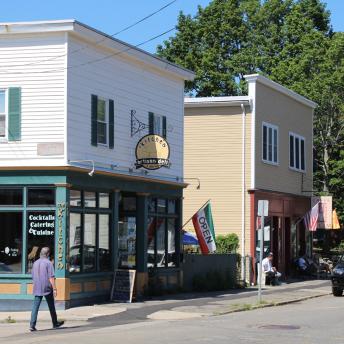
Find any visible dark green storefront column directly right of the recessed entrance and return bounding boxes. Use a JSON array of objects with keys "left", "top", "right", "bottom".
[{"left": 136, "top": 194, "right": 149, "bottom": 296}]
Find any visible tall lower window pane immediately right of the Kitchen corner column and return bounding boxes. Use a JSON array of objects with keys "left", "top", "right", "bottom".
[{"left": 69, "top": 213, "right": 81, "bottom": 272}]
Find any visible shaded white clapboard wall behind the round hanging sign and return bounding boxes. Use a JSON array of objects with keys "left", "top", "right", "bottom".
[{"left": 67, "top": 36, "right": 184, "bottom": 180}]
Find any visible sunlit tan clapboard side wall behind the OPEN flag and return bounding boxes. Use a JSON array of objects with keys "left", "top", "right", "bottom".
[{"left": 183, "top": 106, "right": 251, "bottom": 253}]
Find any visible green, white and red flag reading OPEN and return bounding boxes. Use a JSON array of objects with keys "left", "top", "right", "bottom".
[{"left": 192, "top": 202, "right": 216, "bottom": 254}]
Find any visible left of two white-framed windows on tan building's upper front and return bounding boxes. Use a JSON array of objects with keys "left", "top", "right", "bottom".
[{"left": 262, "top": 122, "right": 278, "bottom": 165}]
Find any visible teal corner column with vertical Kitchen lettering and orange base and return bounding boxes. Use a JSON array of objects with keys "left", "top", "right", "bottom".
[{"left": 55, "top": 184, "right": 70, "bottom": 301}]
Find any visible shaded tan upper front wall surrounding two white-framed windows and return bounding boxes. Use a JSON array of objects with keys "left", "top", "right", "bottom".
[{"left": 255, "top": 82, "right": 313, "bottom": 195}]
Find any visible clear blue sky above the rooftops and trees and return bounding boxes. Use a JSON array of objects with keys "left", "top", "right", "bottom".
[{"left": 0, "top": 0, "right": 344, "bottom": 53}]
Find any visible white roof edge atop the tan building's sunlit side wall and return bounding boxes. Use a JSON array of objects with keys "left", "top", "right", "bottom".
[{"left": 184, "top": 96, "right": 252, "bottom": 108}]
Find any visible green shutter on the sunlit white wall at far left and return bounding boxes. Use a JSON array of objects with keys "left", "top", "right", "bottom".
[{"left": 8, "top": 87, "right": 21, "bottom": 141}]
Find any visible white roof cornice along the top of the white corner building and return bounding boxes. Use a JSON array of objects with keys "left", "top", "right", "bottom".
[{"left": 0, "top": 19, "right": 195, "bottom": 80}]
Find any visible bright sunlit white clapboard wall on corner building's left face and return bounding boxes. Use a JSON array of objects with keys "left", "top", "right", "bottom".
[{"left": 0, "top": 33, "right": 66, "bottom": 166}]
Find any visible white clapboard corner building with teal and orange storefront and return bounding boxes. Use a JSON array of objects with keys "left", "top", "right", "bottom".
[{"left": 0, "top": 21, "right": 193, "bottom": 310}]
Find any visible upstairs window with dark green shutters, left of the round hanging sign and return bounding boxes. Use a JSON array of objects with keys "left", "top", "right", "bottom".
[{"left": 91, "top": 94, "right": 114, "bottom": 148}]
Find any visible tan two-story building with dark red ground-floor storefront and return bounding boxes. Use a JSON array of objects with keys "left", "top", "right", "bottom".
[{"left": 183, "top": 75, "right": 316, "bottom": 283}]
